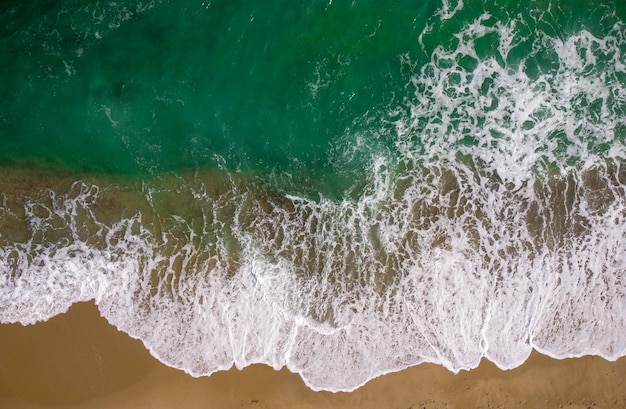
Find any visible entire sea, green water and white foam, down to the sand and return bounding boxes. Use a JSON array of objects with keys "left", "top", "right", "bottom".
[{"left": 0, "top": 0, "right": 626, "bottom": 391}]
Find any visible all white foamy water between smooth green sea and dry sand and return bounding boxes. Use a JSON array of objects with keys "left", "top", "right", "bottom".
[{"left": 0, "top": 3, "right": 626, "bottom": 391}]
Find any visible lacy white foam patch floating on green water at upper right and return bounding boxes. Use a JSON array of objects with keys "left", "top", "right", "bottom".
[{"left": 390, "top": 14, "right": 625, "bottom": 183}]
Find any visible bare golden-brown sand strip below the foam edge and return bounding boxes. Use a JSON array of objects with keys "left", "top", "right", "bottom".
[{"left": 0, "top": 303, "right": 626, "bottom": 409}]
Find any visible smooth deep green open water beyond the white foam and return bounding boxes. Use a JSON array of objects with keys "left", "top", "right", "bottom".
[{"left": 0, "top": 1, "right": 624, "bottom": 193}]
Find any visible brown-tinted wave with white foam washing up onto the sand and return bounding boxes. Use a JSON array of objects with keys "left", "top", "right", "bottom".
[{"left": 0, "top": 156, "right": 626, "bottom": 390}]
